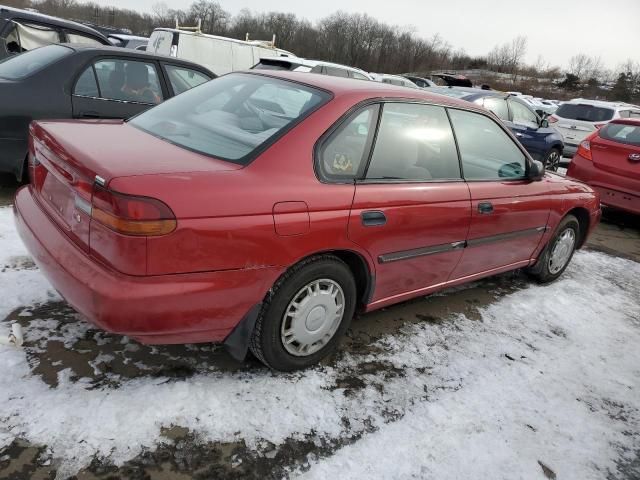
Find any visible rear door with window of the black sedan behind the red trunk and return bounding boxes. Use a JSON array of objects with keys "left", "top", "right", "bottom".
[{"left": 72, "top": 58, "right": 164, "bottom": 119}]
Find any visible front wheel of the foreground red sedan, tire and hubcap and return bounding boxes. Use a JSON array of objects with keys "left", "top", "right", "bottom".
[{"left": 526, "top": 215, "right": 580, "bottom": 283}]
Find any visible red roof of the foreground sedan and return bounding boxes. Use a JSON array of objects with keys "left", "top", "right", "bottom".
[{"left": 244, "top": 70, "right": 484, "bottom": 111}]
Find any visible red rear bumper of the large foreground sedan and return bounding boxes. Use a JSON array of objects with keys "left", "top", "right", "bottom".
[{"left": 14, "top": 186, "right": 282, "bottom": 344}]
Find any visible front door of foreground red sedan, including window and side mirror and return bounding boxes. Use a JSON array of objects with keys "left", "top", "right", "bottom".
[{"left": 449, "top": 109, "right": 549, "bottom": 280}]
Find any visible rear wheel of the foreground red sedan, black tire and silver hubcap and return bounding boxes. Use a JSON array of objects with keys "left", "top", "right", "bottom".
[{"left": 249, "top": 255, "right": 357, "bottom": 372}]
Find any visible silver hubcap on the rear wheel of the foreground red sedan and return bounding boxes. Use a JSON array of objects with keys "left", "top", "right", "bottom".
[{"left": 280, "top": 278, "right": 344, "bottom": 357}]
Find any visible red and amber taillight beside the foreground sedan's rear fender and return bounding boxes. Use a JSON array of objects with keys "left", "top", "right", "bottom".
[{"left": 91, "top": 185, "right": 176, "bottom": 236}]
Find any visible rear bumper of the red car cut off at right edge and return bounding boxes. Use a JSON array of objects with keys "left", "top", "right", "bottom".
[{"left": 567, "top": 155, "right": 640, "bottom": 214}]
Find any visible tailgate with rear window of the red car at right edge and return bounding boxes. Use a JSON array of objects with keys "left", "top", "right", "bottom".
[{"left": 591, "top": 120, "right": 640, "bottom": 181}]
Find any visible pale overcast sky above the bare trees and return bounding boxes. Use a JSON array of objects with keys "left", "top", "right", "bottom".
[{"left": 100, "top": 0, "right": 640, "bottom": 68}]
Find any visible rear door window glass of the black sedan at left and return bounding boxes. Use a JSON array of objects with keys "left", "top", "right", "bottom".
[{"left": 94, "top": 59, "right": 162, "bottom": 105}]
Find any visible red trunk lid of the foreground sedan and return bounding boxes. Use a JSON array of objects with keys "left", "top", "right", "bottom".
[{"left": 29, "top": 120, "right": 241, "bottom": 251}]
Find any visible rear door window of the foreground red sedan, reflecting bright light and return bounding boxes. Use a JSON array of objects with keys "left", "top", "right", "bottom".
[{"left": 366, "top": 103, "right": 461, "bottom": 181}]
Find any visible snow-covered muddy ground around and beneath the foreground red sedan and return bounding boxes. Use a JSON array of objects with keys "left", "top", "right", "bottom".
[{"left": 0, "top": 177, "right": 640, "bottom": 480}]
